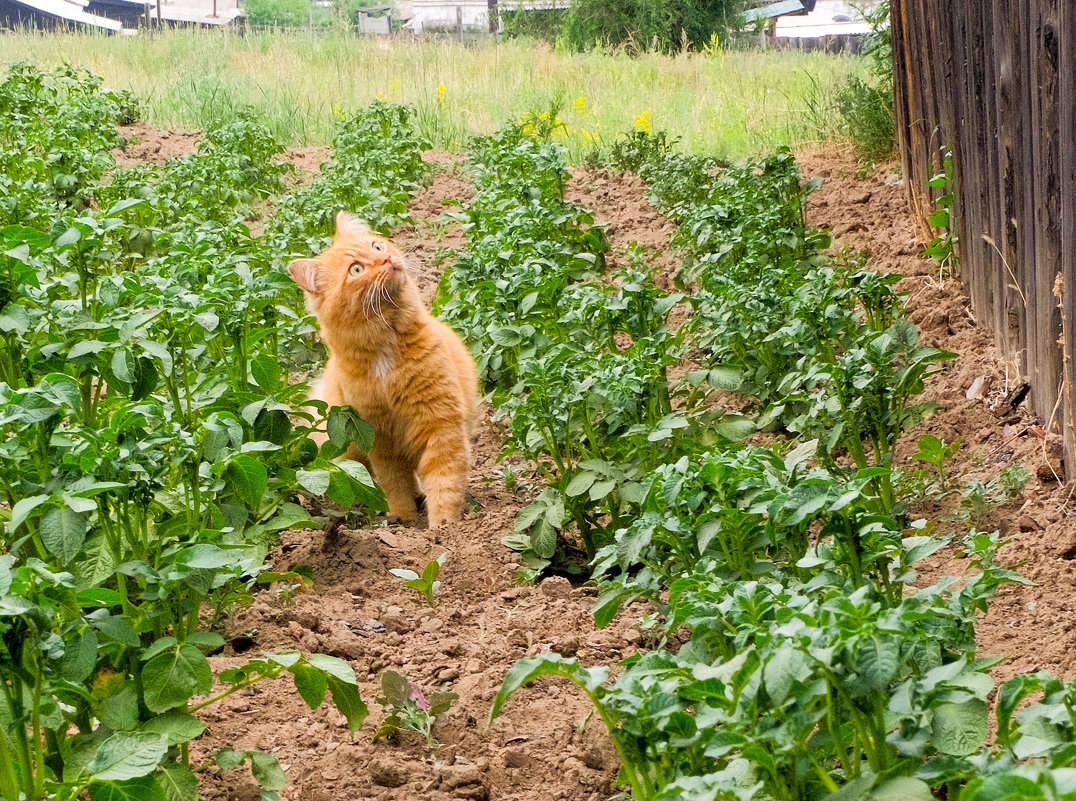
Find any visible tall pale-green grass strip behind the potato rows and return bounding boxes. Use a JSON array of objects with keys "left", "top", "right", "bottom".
[{"left": 0, "top": 30, "right": 864, "bottom": 160}]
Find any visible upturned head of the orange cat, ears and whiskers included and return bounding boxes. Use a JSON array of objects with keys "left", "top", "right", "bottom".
[{"left": 287, "top": 211, "right": 409, "bottom": 320}]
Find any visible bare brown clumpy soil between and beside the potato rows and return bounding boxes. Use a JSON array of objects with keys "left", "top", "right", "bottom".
[{"left": 115, "top": 126, "right": 1076, "bottom": 801}]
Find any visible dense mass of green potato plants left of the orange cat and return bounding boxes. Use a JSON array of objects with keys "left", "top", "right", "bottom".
[{"left": 0, "top": 66, "right": 424, "bottom": 801}]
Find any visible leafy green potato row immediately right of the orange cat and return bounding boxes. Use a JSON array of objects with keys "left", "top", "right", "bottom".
[{"left": 437, "top": 115, "right": 754, "bottom": 571}]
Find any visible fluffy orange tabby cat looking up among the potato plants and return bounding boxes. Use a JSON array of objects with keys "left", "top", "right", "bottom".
[{"left": 287, "top": 212, "right": 478, "bottom": 526}]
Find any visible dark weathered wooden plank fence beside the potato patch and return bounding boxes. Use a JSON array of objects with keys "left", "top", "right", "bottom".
[{"left": 891, "top": 0, "right": 1076, "bottom": 469}]
